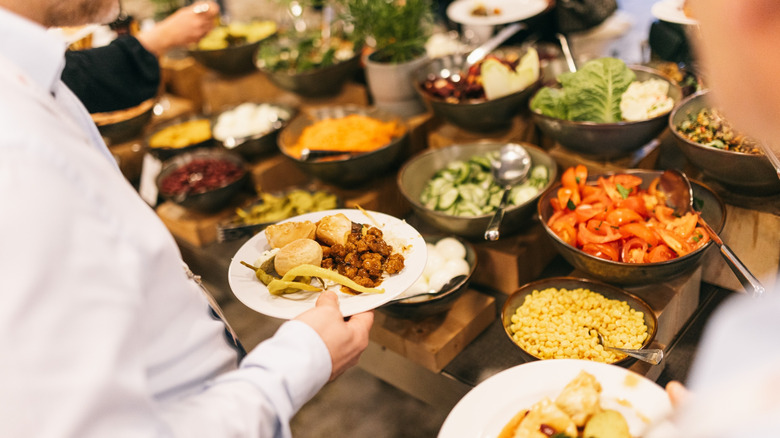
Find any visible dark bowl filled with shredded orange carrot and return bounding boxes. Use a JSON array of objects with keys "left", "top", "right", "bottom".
[{"left": 278, "top": 105, "right": 410, "bottom": 186}]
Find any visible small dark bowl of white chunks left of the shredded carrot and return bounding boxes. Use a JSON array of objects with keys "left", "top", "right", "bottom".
[{"left": 211, "top": 102, "right": 297, "bottom": 160}]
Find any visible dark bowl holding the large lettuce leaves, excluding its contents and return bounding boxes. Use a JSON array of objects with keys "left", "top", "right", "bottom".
[{"left": 529, "top": 66, "right": 682, "bottom": 159}]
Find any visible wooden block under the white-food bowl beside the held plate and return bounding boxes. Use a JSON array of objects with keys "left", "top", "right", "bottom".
[{"left": 371, "top": 289, "right": 496, "bottom": 373}]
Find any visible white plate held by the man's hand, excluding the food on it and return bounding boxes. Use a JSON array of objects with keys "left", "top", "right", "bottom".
[{"left": 228, "top": 209, "right": 428, "bottom": 319}]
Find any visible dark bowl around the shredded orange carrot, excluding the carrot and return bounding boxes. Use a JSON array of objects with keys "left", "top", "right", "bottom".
[{"left": 278, "top": 105, "right": 410, "bottom": 186}]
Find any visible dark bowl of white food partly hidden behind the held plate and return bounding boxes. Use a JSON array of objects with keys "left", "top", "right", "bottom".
[{"left": 382, "top": 235, "right": 477, "bottom": 319}]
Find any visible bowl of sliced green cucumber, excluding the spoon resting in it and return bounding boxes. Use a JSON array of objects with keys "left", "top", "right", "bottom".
[{"left": 398, "top": 142, "right": 557, "bottom": 239}]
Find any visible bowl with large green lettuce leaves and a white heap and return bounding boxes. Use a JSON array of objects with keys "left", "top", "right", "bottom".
[{"left": 529, "top": 58, "right": 682, "bottom": 159}]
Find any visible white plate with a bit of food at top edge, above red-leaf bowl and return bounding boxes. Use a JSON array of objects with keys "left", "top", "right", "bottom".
[{"left": 447, "top": 0, "right": 547, "bottom": 26}]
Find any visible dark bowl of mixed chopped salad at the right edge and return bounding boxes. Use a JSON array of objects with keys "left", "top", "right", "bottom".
[{"left": 669, "top": 90, "right": 780, "bottom": 195}]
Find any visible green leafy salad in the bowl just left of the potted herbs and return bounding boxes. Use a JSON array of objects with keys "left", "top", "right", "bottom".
[{"left": 257, "top": 30, "right": 357, "bottom": 74}]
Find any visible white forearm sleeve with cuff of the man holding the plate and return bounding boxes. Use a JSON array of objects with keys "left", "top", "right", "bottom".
[{"left": 157, "top": 321, "right": 331, "bottom": 437}]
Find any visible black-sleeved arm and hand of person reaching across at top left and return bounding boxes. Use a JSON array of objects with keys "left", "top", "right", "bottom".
[{"left": 62, "top": 1, "right": 220, "bottom": 113}]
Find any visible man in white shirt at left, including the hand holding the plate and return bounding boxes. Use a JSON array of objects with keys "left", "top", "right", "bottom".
[{"left": 0, "top": 0, "right": 373, "bottom": 438}]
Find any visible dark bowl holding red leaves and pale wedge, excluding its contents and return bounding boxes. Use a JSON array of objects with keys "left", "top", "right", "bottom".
[{"left": 412, "top": 48, "right": 541, "bottom": 132}]
